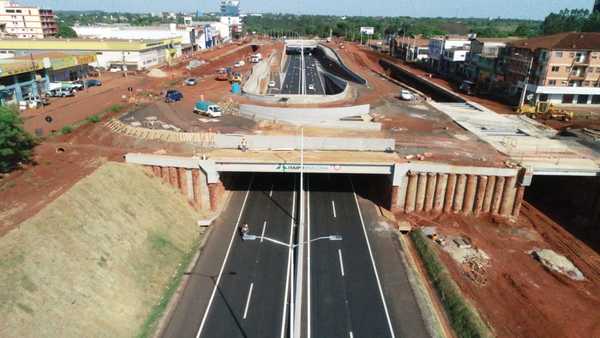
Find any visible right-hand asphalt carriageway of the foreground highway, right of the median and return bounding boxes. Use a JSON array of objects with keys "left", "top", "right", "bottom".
[{"left": 308, "top": 175, "right": 392, "bottom": 338}]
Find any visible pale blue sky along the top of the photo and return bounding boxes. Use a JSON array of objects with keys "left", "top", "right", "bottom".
[{"left": 21, "top": 0, "right": 594, "bottom": 19}]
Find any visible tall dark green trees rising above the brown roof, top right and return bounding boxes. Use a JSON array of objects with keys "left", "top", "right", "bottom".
[{"left": 542, "top": 9, "right": 600, "bottom": 35}]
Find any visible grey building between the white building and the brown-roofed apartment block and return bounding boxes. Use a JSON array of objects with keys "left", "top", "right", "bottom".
[{"left": 464, "top": 38, "right": 516, "bottom": 90}]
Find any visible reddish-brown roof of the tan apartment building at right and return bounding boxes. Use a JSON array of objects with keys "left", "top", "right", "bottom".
[{"left": 509, "top": 32, "right": 600, "bottom": 51}]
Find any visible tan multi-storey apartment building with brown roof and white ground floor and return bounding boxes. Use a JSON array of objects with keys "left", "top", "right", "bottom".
[{"left": 504, "top": 32, "right": 600, "bottom": 105}]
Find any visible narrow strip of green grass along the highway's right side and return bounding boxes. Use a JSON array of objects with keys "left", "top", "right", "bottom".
[{"left": 411, "top": 230, "right": 491, "bottom": 338}]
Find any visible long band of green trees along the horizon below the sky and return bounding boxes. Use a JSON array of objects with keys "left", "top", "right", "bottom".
[{"left": 244, "top": 14, "right": 540, "bottom": 41}]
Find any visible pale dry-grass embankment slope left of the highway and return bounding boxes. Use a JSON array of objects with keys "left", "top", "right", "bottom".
[{"left": 0, "top": 163, "right": 199, "bottom": 337}]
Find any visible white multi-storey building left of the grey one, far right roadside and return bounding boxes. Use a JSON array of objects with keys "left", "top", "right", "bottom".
[{"left": 429, "top": 35, "right": 471, "bottom": 75}]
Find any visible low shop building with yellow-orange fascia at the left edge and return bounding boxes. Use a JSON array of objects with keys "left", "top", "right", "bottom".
[{"left": 0, "top": 52, "right": 96, "bottom": 105}]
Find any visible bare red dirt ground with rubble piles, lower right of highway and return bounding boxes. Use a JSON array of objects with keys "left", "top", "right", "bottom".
[{"left": 408, "top": 207, "right": 600, "bottom": 337}]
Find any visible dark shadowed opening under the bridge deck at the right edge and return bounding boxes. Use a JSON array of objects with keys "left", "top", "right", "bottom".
[{"left": 525, "top": 176, "right": 600, "bottom": 253}]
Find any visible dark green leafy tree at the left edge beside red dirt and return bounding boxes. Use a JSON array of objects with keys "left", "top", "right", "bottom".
[{"left": 0, "top": 106, "right": 35, "bottom": 172}]
